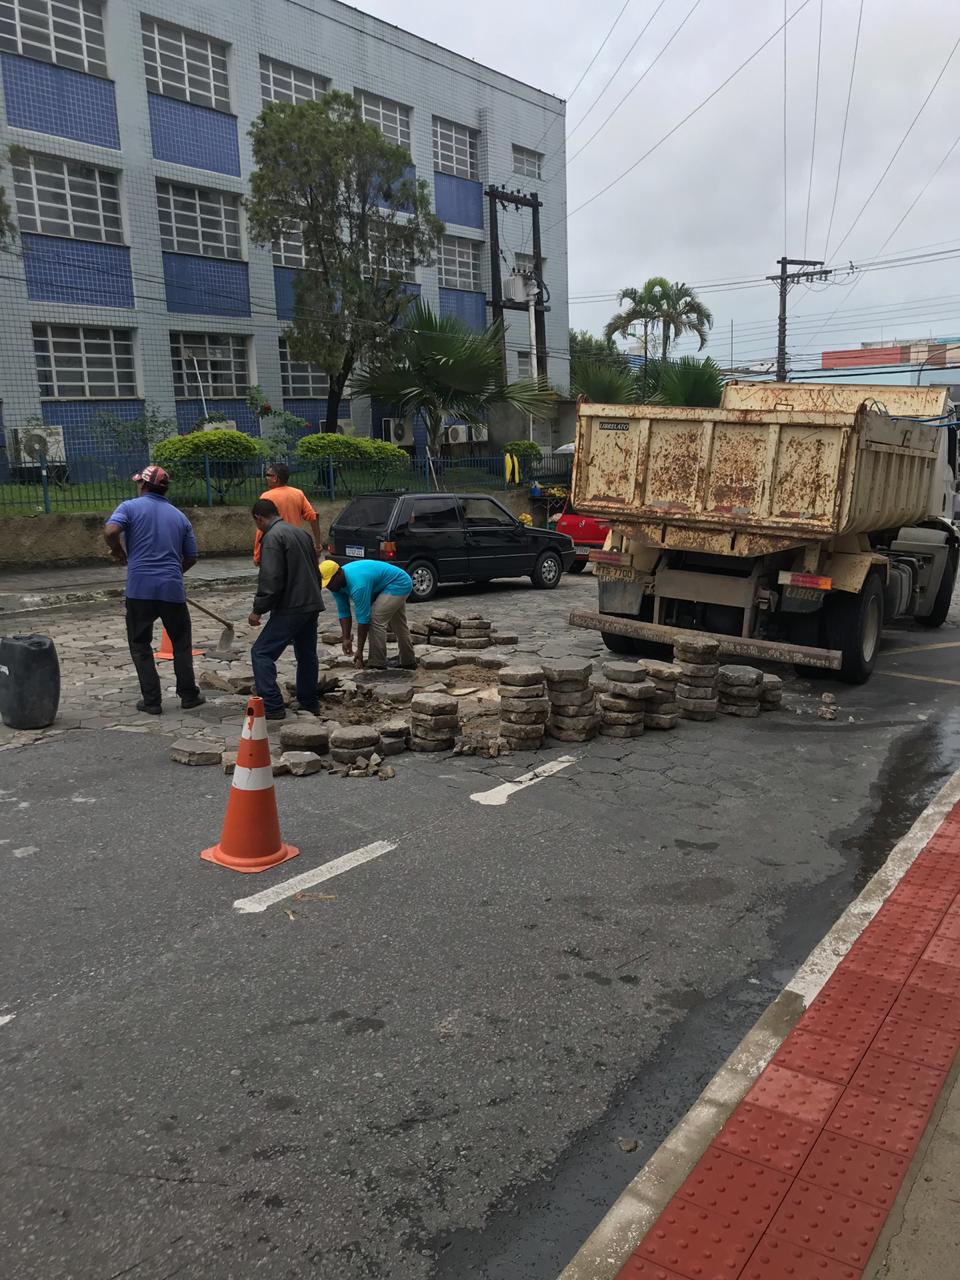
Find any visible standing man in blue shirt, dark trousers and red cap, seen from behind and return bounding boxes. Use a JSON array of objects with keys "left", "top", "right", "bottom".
[{"left": 104, "top": 466, "right": 206, "bottom": 716}]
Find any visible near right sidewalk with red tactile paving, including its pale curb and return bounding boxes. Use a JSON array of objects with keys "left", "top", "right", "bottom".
[{"left": 563, "top": 774, "right": 960, "bottom": 1280}]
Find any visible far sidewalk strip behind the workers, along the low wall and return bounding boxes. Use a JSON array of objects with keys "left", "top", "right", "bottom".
[{"left": 0, "top": 556, "right": 257, "bottom": 616}]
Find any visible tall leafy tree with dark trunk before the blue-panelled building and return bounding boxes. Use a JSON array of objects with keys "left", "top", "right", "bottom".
[{"left": 246, "top": 92, "right": 444, "bottom": 431}]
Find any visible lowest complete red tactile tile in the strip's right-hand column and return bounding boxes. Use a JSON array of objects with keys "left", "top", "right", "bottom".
[{"left": 769, "top": 1179, "right": 887, "bottom": 1267}]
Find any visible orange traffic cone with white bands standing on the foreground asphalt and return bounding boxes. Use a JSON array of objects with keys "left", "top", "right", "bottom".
[{"left": 200, "top": 698, "right": 300, "bottom": 872}]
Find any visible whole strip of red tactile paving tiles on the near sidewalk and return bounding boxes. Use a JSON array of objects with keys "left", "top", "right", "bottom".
[{"left": 618, "top": 805, "right": 960, "bottom": 1280}]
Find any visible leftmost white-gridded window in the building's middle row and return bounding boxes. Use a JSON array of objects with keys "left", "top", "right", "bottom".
[{"left": 12, "top": 154, "right": 123, "bottom": 244}]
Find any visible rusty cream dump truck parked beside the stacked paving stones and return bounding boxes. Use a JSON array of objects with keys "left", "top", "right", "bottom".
[{"left": 571, "top": 381, "right": 960, "bottom": 684}]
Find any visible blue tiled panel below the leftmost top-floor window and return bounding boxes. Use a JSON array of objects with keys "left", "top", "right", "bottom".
[{"left": 0, "top": 54, "right": 120, "bottom": 151}]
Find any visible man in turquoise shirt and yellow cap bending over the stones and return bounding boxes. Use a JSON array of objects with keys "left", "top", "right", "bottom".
[{"left": 320, "top": 559, "right": 417, "bottom": 671}]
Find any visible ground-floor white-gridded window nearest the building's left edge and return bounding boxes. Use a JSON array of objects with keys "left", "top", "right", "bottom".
[{"left": 33, "top": 324, "right": 137, "bottom": 399}]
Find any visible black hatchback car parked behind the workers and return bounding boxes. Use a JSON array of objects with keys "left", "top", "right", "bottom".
[{"left": 330, "top": 493, "right": 575, "bottom": 600}]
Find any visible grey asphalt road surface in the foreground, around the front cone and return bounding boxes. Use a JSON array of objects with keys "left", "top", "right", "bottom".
[{"left": 0, "top": 576, "right": 960, "bottom": 1280}]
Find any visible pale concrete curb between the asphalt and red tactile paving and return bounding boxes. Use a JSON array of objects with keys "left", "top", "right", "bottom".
[{"left": 559, "top": 769, "right": 960, "bottom": 1280}]
